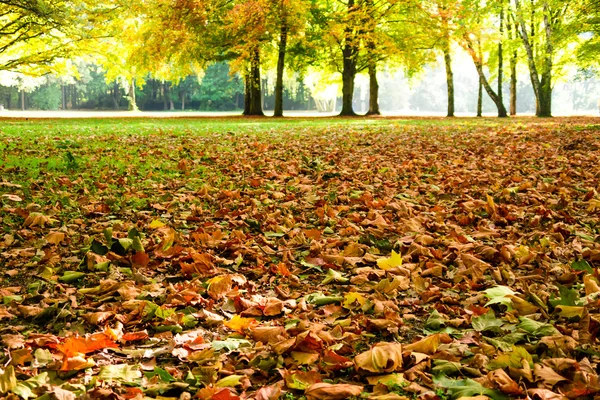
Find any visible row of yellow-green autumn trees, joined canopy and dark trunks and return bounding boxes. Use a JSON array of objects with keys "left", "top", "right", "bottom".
[{"left": 0, "top": 0, "right": 600, "bottom": 116}]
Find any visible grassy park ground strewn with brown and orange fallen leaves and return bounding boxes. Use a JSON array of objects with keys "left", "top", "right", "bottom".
[{"left": 0, "top": 118, "right": 600, "bottom": 400}]
